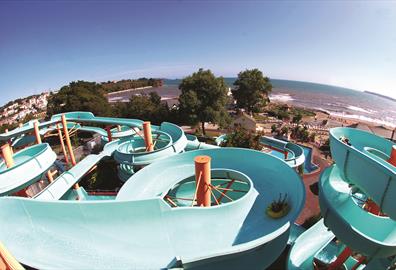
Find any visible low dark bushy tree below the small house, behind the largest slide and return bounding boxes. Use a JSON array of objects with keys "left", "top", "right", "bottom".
[{"left": 221, "top": 127, "right": 262, "bottom": 150}]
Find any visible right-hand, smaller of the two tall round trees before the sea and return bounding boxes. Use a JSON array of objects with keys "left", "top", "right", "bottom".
[{"left": 232, "top": 69, "right": 272, "bottom": 112}]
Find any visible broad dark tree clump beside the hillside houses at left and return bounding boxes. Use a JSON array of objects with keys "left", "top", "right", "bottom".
[{"left": 47, "top": 81, "right": 111, "bottom": 116}]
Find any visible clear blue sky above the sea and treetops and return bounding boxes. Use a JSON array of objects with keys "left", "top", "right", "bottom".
[{"left": 0, "top": 0, "right": 396, "bottom": 105}]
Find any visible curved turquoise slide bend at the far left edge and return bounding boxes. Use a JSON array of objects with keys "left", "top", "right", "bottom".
[{"left": 0, "top": 143, "right": 56, "bottom": 196}]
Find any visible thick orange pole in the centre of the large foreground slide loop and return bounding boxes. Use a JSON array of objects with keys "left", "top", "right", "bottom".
[{"left": 194, "top": 156, "right": 211, "bottom": 207}]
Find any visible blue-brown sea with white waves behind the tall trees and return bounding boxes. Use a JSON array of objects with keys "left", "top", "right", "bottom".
[{"left": 107, "top": 78, "right": 396, "bottom": 128}]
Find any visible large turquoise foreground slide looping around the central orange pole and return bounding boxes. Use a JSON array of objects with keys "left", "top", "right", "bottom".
[{"left": 0, "top": 148, "right": 305, "bottom": 270}]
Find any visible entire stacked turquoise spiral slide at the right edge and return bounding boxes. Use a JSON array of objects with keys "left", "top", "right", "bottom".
[{"left": 289, "top": 128, "right": 396, "bottom": 269}]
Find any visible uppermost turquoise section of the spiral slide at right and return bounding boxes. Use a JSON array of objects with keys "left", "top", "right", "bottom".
[{"left": 330, "top": 128, "right": 396, "bottom": 220}]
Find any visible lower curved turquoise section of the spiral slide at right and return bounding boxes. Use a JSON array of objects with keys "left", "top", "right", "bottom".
[{"left": 319, "top": 165, "right": 396, "bottom": 258}]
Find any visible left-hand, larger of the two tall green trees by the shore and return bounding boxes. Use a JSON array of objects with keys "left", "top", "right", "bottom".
[{"left": 179, "top": 69, "right": 229, "bottom": 134}]
